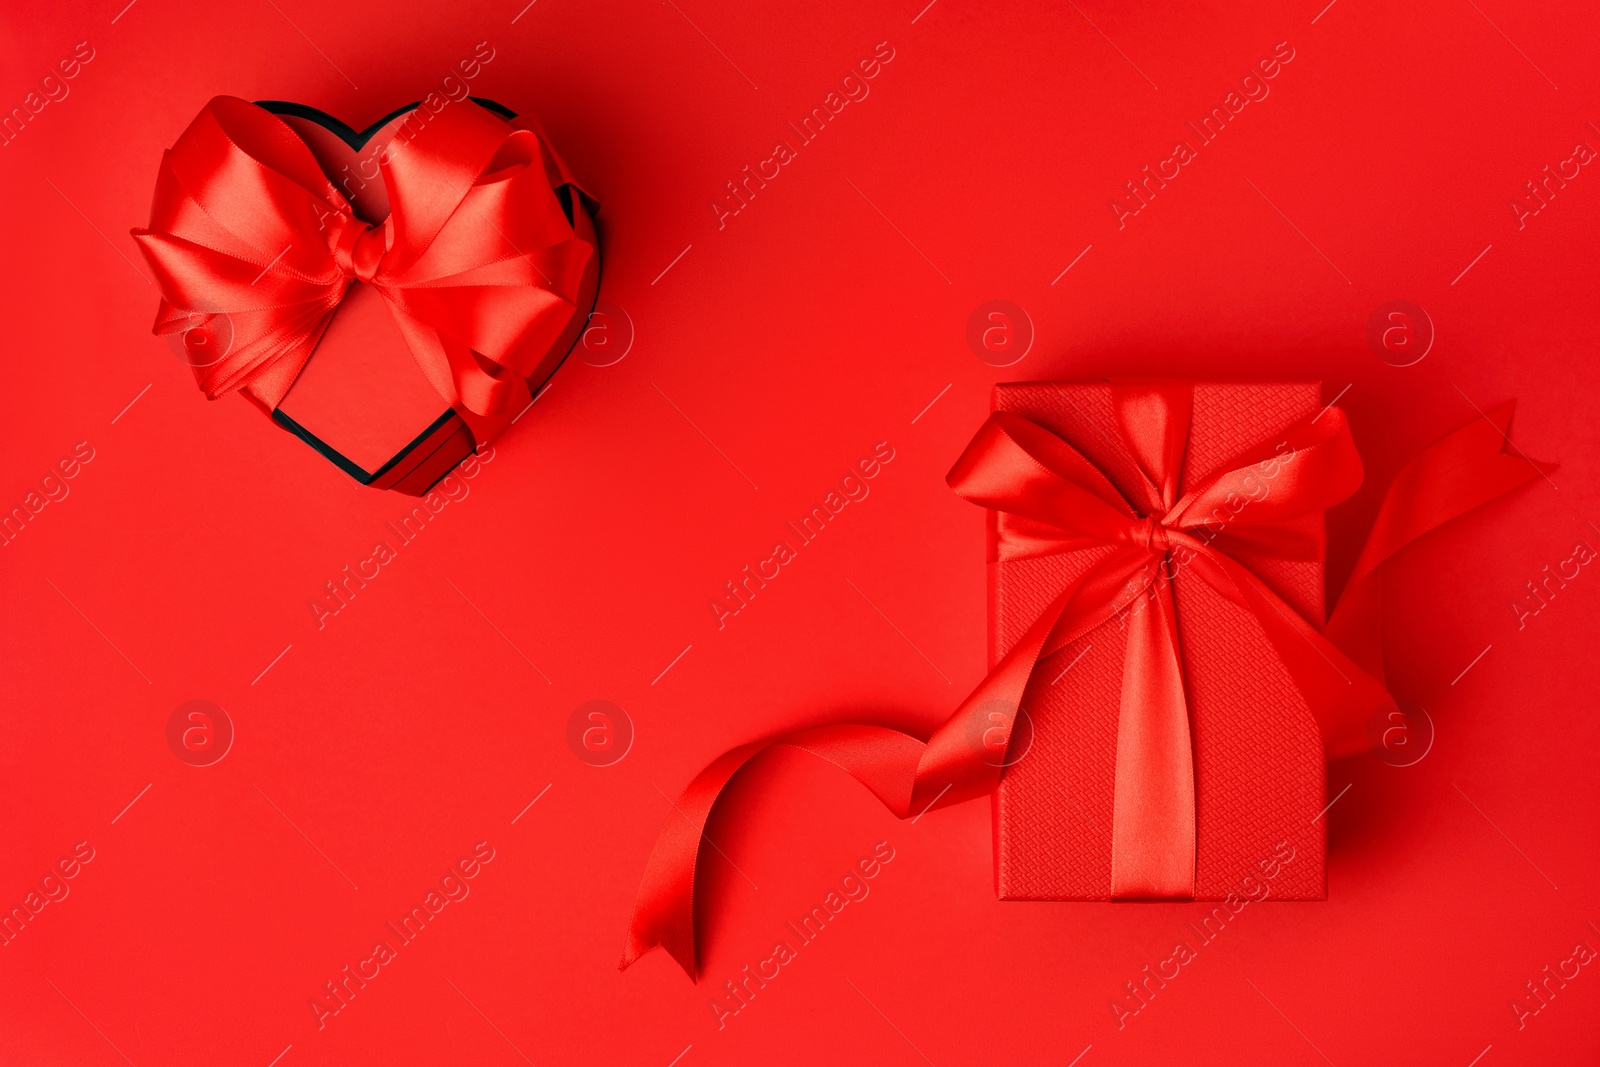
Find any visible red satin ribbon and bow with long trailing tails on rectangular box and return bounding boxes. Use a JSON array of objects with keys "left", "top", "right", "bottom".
[{"left": 621, "top": 382, "right": 1554, "bottom": 977}]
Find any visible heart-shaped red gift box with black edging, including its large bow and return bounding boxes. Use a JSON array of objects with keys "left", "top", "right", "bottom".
[{"left": 133, "top": 96, "right": 600, "bottom": 496}]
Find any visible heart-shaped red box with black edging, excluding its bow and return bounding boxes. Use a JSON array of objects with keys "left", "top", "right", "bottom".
[{"left": 259, "top": 98, "right": 600, "bottom": 496}]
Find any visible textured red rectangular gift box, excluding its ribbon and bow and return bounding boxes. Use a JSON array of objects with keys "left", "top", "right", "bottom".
[{"left": 989, "top": 382, "right": 1326, "bottom": 901}]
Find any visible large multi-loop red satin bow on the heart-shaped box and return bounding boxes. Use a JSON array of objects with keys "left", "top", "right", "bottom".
[{"left": 133, "top": 96, "right": 590, "bottom": 414}]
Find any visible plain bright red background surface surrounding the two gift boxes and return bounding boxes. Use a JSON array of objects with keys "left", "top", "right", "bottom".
[{"left": 0, "top": 0, "right": 1600, "bottom": 1067}]
